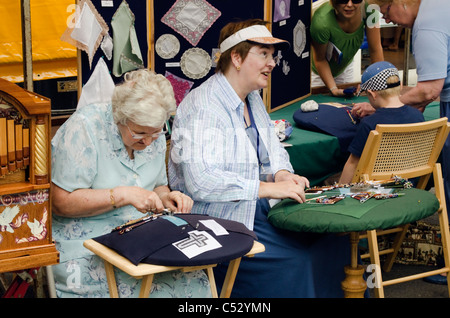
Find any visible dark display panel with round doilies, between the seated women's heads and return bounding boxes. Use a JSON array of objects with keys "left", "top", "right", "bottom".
[{"left": 150, "top": 0, "right": 269, "bottom": 107}]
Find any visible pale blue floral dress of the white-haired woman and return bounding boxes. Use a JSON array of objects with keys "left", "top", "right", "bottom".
[{"left": 52, "top": 104, "right": 210, "bottom": 297}]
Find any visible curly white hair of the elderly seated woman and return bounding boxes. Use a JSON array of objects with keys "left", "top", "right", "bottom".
[{"left": 111, "top": 69, "right": 176, "bottom": 128}]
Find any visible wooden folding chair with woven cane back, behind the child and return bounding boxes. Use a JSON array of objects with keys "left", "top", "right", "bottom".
[{"left": 352, "top": 117, "right": 450, "bottom": 297}]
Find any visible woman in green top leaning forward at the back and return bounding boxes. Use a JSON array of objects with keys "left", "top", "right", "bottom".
[{"left": 311, "top": 0, "right": 384, "bottom": 96}]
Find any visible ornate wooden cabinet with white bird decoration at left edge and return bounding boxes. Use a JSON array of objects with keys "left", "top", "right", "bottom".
[{"left": 0, "top": 78, "right": 59, "bottom": 272}]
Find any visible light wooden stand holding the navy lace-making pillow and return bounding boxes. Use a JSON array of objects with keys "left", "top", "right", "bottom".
[{"left": 83, "top": 239, "right": 265, "bottom": 298}]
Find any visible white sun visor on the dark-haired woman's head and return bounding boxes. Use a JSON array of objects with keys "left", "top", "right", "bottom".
[{"left": 220, "top": 25, "right": 290, "bottom": 53}]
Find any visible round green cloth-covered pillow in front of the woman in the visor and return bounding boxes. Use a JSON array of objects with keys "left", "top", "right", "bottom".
[{"left": 268, "top": 189, "right": 439, "bottom": 233}]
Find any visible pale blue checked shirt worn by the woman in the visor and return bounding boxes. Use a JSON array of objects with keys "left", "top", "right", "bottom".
[{"left": 169, "top": 73, "right": 293, "bottom": 229}]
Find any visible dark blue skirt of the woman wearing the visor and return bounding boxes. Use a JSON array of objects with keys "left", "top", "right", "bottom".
[{"left": 214, "top": 199, "right": 356, "bottom": 298}]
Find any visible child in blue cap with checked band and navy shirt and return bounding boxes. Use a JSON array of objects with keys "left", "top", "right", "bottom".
[{"left": 339, "top": 61, "right": 425, "bottom": 183}]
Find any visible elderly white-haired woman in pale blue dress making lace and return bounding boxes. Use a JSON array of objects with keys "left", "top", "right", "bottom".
[{"left": 52, "top": 69, "right": 210, "bottom": 297}]
